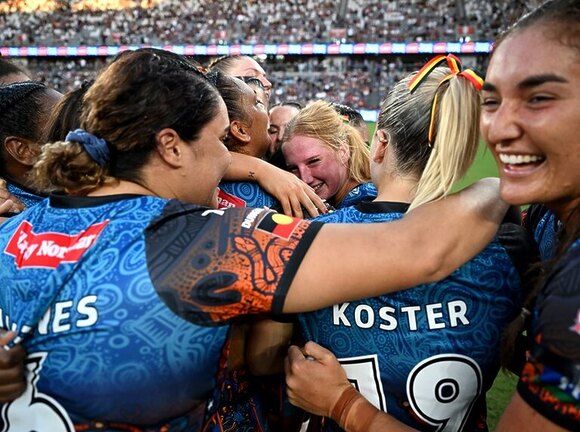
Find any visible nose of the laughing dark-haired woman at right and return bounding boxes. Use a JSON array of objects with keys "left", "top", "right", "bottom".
[{"left": 480, "top": 100, "right": 522, "bottom": 147}]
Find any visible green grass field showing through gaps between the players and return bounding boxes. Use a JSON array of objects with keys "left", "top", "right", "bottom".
[{"left": 369, "top": 123, "right": 517, "bottom": 431}]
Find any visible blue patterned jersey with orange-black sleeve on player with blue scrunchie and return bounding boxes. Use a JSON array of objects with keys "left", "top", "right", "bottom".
[{"left": 0, "top": 195, "right": 318, "bottom": 432}]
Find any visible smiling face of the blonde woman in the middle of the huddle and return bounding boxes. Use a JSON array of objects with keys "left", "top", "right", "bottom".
[{"left": 282, "top": 135, "right": 349, "bottom": 199}]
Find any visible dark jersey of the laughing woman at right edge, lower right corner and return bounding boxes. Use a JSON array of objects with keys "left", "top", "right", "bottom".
[{"left": 518, "top": 240, "right": 580, "bottom": 431}]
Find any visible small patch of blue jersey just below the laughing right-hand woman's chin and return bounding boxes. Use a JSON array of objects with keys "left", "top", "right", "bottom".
[{"left": 523, "top": 204, "right": 562, "bottom": 261}]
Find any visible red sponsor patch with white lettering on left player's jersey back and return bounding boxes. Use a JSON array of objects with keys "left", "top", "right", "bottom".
[{"left": 4, "top": 221, "right": 109, "bottom": 269}]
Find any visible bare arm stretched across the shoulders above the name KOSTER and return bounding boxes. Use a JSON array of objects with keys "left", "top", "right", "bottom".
[{"left": 284, "top": 177, "right": 507, "bottom": 313}]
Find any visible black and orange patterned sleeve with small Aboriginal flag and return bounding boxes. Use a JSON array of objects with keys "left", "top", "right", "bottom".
[{"left": 146, "top": 202, "right": 322, "bottom": 325}]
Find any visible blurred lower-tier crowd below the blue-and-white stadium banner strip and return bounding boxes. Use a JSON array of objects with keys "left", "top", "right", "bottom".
[{"left": 17, "top": 57, "right": 448, "bottom": 110}]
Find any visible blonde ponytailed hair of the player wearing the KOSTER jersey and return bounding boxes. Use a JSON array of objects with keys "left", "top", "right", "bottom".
[{"left": 377, "top": 67, "right": 481, "bottom": 210}]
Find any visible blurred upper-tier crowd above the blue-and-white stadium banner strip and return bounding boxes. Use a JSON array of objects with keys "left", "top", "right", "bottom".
[{"left": 0, "top": 0, "right": 531, "bottom": 46}]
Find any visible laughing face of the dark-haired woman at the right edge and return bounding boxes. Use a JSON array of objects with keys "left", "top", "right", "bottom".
[{"left": 481, "top": 26, "right": 580, "bottom": 217}]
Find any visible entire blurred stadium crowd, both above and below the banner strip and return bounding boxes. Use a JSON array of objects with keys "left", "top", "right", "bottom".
[{"left": 0, "top": 0, "right": 508, "bottom": 110}]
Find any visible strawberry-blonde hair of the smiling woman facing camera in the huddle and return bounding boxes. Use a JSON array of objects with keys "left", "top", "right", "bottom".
[{"left": 283, "top": 101, "right": 371, "bottom": 183}]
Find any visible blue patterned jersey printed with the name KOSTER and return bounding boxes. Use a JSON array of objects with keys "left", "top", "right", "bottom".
[{"left": 300, "top": 202, "right": 531, "bottom": 431}]
